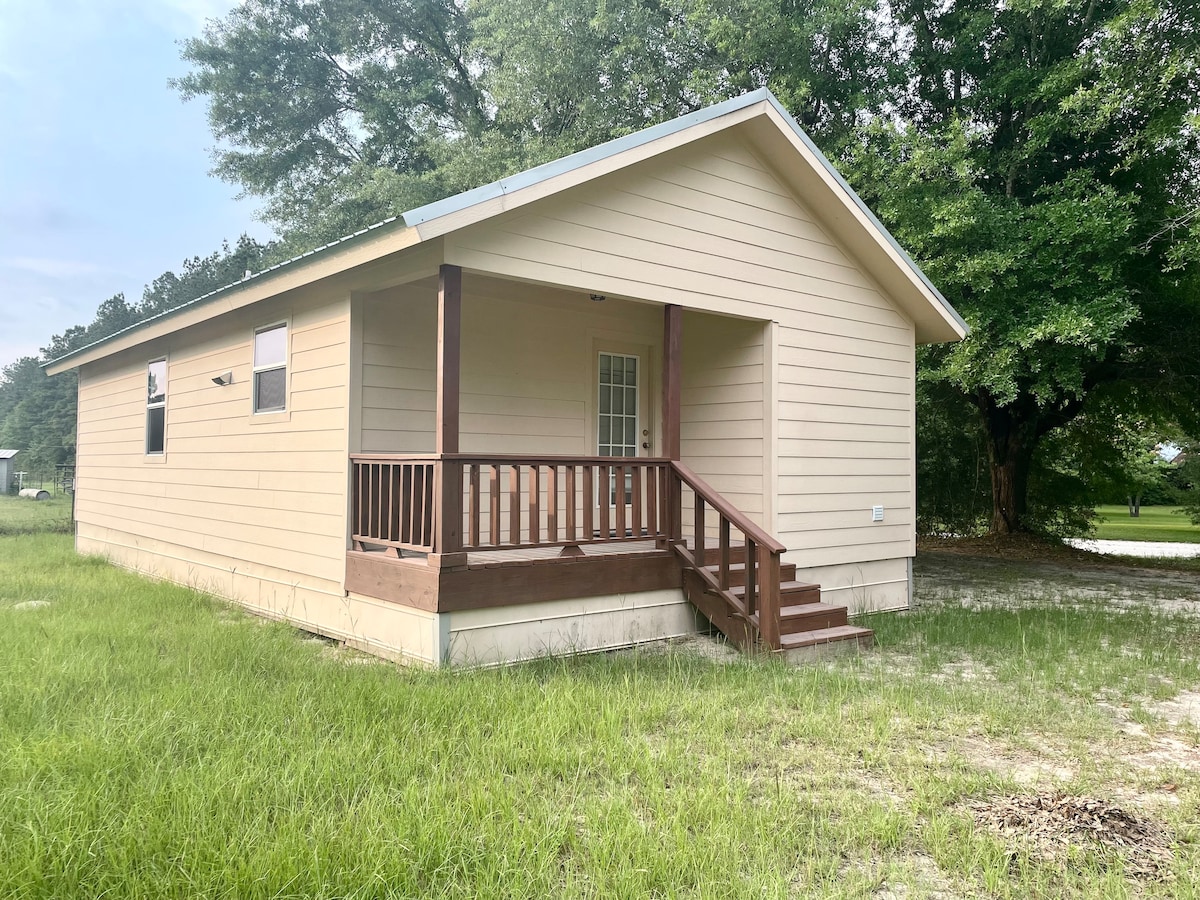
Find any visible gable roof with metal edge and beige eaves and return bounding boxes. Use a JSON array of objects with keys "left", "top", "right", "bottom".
[{"left": 44, "top": 88, "right": 967, "bottom": 374}]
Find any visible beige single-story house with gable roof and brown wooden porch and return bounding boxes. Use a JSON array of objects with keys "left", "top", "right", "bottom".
[{"left": 47, "top": 90, "right": 966, "bottom": 664}]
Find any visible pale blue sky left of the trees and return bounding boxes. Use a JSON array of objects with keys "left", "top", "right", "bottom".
[{"left": 0, "top": 0, "right": 272, "bottom": 367}]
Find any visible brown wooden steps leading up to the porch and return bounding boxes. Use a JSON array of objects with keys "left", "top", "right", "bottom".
[{"left": 680, "top": 546, "right": 874, "bottom": 660}]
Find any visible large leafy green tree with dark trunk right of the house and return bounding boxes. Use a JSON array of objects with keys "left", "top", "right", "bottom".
[{"left": 851, "top": 0, "right": 1200, "bottom": 532}]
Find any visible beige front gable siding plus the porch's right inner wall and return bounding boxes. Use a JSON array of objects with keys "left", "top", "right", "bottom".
[{"left": 445, "top": 134, "right": 914, "bottom": 577}]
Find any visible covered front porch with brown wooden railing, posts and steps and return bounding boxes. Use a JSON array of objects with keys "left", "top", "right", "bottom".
[{"left": 346, "top": 265, "right": 869, "bottom": 661}]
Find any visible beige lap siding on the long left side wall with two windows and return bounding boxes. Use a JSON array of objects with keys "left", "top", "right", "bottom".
[{"left": 76, "top": 296, "right": 349, "bottom": 593}]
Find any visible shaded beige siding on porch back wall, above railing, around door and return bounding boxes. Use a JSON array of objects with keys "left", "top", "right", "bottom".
[{"left": 362, "top": 274, "right": 662, "bottom": 455}]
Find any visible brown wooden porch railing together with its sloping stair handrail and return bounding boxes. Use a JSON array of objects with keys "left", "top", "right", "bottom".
[{"left": 350, "top": 454, "right": 786, "bottom": 649}]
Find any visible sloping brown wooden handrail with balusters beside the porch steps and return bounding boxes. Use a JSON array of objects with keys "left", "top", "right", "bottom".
[{"left": 671, "top": 460, "right": 787, "bottom": 650}]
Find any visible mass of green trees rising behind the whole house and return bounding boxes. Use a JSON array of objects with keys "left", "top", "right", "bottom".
[{"left": 9, "top": 0, "right": 1200, "bottom": 532}]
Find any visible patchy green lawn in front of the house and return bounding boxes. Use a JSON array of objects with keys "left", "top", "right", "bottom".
[{"left": 0, "top": 534, "right": 1200, "bottom": 898}]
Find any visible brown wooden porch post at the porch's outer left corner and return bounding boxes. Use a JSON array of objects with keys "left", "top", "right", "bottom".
[{"left": 431, "top": 265, "right": 466, "bottom": 565}]
